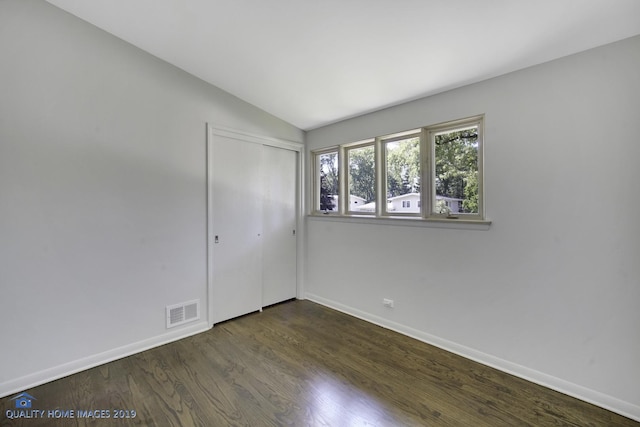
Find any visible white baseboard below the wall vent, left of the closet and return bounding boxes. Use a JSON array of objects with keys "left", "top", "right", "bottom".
[{"left": 0, "top": 321, "right": 209, "bottom": 398}]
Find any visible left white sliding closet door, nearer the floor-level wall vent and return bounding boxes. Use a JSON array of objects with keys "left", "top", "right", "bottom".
[{"left": 211, "top": 135, "right": 263, "bottom": 323}]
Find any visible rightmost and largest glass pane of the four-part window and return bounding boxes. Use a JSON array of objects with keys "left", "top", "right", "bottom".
[{"left": 432, "top": 126, "right": 478, "bottom": 214}]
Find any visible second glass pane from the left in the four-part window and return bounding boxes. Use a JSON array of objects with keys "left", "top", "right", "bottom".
[{"left": 347, "top": 145, "right": 376, "bottom": 212}]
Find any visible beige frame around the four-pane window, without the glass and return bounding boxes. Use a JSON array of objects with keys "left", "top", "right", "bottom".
[{"left": 310, "top": 114, "right": 490, "bottom": 224}]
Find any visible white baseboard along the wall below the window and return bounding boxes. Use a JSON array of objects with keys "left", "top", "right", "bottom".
[{"left": 305, "top": 293, "right": 640, "bottom": 421}]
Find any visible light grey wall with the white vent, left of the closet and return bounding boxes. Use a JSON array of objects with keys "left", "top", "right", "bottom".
[{"left": 0, "top": 0, "right": 303, "bottom": 396}]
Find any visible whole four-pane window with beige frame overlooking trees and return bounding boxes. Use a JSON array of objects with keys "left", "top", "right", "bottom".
[{"left": 312, "top": 116, "right": 484, "bottom": 220}]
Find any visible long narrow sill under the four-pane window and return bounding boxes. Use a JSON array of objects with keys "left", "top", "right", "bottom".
[{"left": 307, "top": 213, "right": 491, "bottom": 230}]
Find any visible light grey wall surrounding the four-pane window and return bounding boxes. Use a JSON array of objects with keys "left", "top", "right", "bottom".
[{"left": 306, "top": 37, "right": 640, "bottom": 420}]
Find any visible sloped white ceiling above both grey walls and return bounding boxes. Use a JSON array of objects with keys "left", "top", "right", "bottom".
[{"left": 48, "top": 0, "right": 640, "bottom": 130}]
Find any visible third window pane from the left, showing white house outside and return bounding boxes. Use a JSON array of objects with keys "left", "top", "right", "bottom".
[{"left": 385, "top": 137, "right": 420, "bottom": 213}]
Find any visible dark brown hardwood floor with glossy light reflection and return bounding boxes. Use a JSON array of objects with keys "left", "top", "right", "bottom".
[{"left": 0, "top": 301, "right": 640, "bottom": 427}]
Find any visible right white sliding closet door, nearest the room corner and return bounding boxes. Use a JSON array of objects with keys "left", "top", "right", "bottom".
[{"left": 262, "top": 146, "right": 298, "bottom": 307}]
